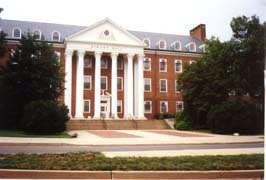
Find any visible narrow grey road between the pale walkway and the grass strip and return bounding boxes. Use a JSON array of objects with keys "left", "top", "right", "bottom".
[{"left": 0, "top": 143, "right": 264, "bottom": 153}]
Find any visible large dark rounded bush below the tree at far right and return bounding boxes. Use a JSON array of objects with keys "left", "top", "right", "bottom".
[{"left": 207, "top": 100, "right": 264, "bottom": 134}]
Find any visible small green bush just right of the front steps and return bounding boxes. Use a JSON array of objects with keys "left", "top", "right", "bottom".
[{"left": 174, "top": 112, "right": 192, "bottom": 130}]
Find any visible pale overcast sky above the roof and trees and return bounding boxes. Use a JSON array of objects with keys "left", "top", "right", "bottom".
[{"left": 0, "top": 0, "right": 266, "bottom": 40}]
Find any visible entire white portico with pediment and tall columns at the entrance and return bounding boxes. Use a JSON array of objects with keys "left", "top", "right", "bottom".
[{"left": 64, "top": 19, "right": 145, "bottom": 119}]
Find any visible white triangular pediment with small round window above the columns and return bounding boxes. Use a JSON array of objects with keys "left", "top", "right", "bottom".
[{"left": 65, "top": 18, "right": 146, "bottom": 47}]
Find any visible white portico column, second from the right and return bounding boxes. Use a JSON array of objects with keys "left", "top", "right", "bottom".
[{"left": 125, "top": 54, "right": 134, "bottom": 118}]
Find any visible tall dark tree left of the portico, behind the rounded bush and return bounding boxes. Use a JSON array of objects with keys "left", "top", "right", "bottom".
[{"left": 0, "top": 34, "right": 64, "bottom": 128}]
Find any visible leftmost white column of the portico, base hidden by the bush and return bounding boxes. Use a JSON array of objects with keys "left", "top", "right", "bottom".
[{"left": 64, "top": 49, "right": 73, "bottom": 117}]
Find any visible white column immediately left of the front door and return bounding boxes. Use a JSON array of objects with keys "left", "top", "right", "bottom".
[{"left": 94, "top": 52, "right": 102, "bottom": 119}]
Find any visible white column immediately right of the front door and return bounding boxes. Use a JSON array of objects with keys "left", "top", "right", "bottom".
[{"left": 111, "top": 53, "right": 118, "bottom": 118}]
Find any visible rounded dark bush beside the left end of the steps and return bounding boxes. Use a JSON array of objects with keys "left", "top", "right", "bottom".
[{"left": 21, "top": 100, "right": 69, "bottom": 134}]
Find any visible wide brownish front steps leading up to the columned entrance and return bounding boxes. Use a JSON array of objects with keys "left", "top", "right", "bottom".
[{"left": 66, "top": 120, "right": 171, "bottom": 130}]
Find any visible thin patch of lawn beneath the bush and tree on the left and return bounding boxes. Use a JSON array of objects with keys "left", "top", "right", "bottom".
[{"left": 0, "top": 130, "right": 71, "bottom": 138}]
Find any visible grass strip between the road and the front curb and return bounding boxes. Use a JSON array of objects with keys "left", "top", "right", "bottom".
[{"left": 0, "top": 152, "right": 264, "bottom": 171}]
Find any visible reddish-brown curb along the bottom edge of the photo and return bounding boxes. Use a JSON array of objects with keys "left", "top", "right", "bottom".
[{"left": 0, "top": 169, "right": 264, "bottom": 179}]
